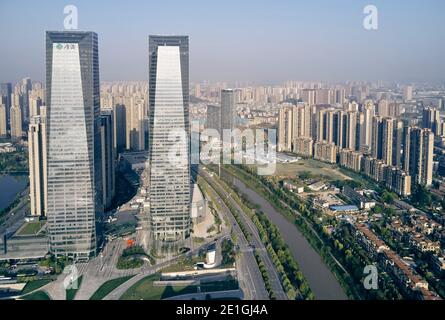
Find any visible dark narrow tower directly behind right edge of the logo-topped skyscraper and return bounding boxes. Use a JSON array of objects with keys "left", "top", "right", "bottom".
[{"left": 100, "top": 109, "right": 116, "bottom": 208}]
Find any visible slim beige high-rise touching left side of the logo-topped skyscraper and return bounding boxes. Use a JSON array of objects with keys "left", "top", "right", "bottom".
[{"left": 28, "top": 116, "right": 47, "bottom": 217}]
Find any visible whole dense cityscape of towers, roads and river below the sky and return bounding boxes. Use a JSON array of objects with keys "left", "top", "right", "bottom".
[{"left": 0, "top": 31, "right": 445, "bottom": 300}]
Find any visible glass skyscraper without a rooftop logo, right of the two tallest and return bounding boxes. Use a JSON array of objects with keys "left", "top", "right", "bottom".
[{"left": 149, "top": 36, "right": 191, "bottom": 251}]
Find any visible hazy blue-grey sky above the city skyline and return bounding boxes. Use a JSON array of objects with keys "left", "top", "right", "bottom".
[{"left": 0, "top": 0, "right": 445, "bottom": 84}]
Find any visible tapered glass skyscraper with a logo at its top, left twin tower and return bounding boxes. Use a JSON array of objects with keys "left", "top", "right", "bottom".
[{"left": 46, "top": 31, "right": 103, "bottom": 260}]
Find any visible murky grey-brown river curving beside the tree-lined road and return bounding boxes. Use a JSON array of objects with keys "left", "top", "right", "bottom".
[{"left": 224, "top": 171, "right": 348, "bottom": 300}]
